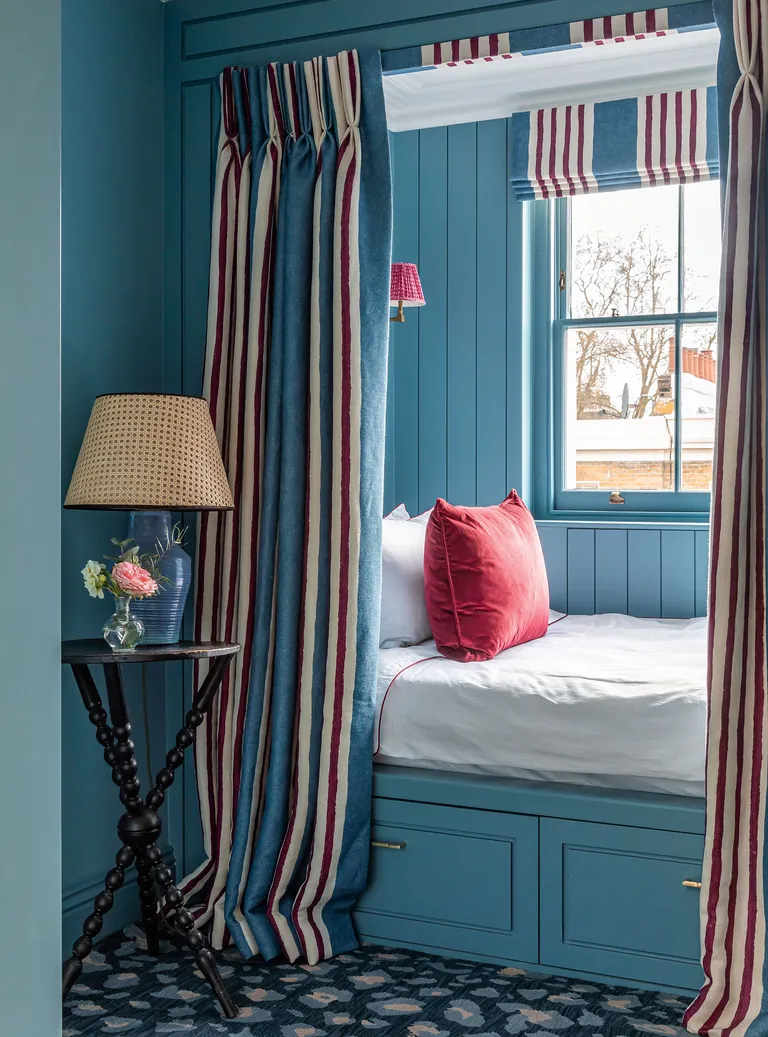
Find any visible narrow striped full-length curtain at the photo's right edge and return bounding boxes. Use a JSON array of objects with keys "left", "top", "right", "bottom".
[{"left": 685, "top": 0, "right": 768, "bottom": 1037}]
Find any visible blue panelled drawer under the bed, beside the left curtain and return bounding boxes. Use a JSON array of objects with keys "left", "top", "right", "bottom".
[{"left": 355, "top": 798, "right": 539, "bottom": 962}]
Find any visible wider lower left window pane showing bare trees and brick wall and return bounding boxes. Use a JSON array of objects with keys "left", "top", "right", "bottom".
[{"left": 564, "top": 327, "right": 675, "bottom": 492}]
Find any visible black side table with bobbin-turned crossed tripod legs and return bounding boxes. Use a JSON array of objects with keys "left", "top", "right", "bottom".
[{"left": 61, "top": 640, "right": 240, "bottom": 1019}]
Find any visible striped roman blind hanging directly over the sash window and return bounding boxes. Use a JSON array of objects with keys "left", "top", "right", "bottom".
[{"left": 511, "top": 86, "right": 719, "bottom": 200}]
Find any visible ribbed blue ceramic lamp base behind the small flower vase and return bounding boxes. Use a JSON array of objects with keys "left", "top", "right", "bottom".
[{"left": 129, "top": 511, "right": 192, "bottom": 645}]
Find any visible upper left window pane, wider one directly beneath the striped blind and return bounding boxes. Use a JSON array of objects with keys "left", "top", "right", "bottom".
[{"left": 570, "top": 187, "right": 680, "bottom": 317}]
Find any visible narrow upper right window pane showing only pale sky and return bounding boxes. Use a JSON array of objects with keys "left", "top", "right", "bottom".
[{"left": 683, "top": 180, "right": 720, "bottom": 313}]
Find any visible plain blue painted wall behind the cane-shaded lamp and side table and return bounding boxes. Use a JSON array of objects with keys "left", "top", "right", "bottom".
[{"left": 61, "top": 0, "right": 166, "bottom": 945}]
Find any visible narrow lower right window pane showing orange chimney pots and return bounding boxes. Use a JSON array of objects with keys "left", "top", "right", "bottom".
[{"left": 680, "top": 324, "right": 717, "bottom": 493}]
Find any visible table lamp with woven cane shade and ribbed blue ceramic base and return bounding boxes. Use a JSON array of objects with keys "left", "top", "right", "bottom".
[{"left": 64, "top": 393, "right": 234, "bottom": 645}]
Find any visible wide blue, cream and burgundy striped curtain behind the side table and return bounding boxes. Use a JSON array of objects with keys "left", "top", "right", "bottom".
[{"left": 182, "top": 51, "right": 392, "bottom": 963}]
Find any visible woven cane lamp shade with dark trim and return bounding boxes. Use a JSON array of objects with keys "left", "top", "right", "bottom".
[{"left": 64, "top": 393, "right": 233, "bottom": 511}]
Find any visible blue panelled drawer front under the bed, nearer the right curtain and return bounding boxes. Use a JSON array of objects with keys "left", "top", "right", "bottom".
[{"left": 540, "top": 818, "right": 704, "bottom": 989}]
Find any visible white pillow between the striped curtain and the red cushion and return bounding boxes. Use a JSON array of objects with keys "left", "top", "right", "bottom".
[{"left": 378, "top": 508, "right": 432, "bottom": 648}]
